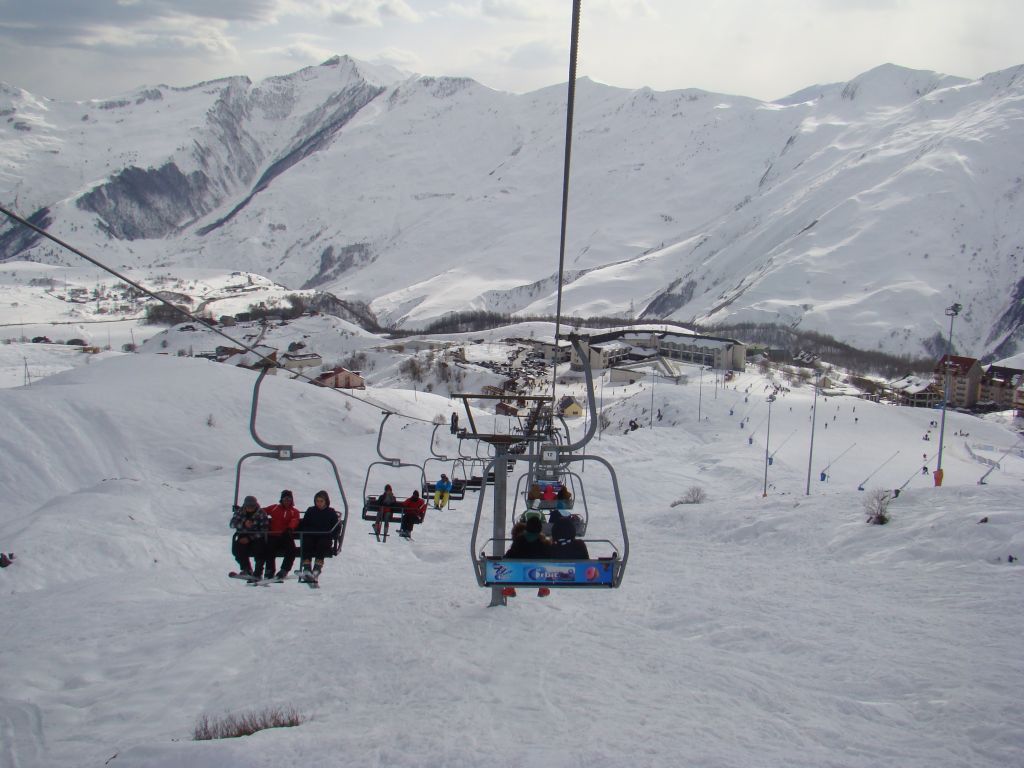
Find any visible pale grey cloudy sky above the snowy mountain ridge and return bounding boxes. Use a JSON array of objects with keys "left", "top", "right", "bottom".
[{"left": 0, "top": 0, "right": 1024, "bottom": 99}]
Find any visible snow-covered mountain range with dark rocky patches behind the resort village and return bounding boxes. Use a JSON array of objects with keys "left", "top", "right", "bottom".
[{"left": 0, "top": 57, "right": 1024, "bottom": 356}]
